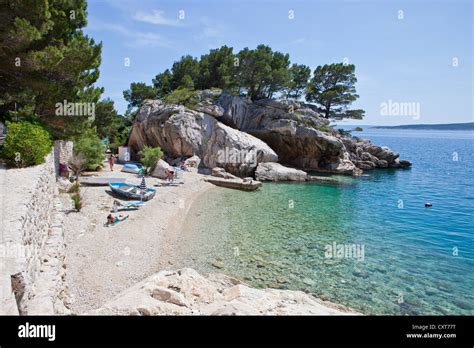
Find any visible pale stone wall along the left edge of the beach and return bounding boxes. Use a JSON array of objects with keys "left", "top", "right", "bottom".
[{"left": 0, "top": 150, "right": 68, "bottom": 315}]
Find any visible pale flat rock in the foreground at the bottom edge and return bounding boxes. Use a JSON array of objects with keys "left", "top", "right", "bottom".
[{"left": 92, "top": 268, "right": 358, "bottom": 315}]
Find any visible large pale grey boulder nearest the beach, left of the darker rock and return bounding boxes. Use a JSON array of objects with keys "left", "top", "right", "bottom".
[{"left": 129, "top": 100, "right": 278, "bottom": 176}]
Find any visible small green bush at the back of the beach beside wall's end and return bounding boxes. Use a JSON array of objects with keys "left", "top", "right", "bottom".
[{"left": 74, "top": 130, "right": 105, "bottom": 170}]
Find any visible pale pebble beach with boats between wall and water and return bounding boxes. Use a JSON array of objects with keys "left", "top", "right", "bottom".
[{"left": 61, "top": 165, "right": 214, "bottom": 314}]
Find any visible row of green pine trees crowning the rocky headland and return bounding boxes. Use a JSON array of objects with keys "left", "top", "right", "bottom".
[{"left": 124, "top": 45, "right": 364, "bottom": 119}]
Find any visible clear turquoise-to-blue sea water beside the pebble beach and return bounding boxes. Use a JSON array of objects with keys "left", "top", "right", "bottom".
[{"left": 177, "top": 130, "right": 474, "bottom": 315}]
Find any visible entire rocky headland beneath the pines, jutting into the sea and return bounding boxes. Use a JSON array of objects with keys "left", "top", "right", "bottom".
[{"left": 129, "top": 89, "right": 411, "bottom": 177}]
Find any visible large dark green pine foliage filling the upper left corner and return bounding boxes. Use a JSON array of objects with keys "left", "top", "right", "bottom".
[{"left": 0, "top": 0, "right": 103, "bottom": 137}]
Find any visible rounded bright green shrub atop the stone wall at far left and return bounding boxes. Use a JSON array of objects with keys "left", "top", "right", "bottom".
[{"left": 3, "top": 121, "right": 53, "bottom": 167}]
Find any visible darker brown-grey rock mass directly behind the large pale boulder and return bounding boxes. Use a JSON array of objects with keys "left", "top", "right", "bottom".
[{"left": 217, "top": 93, "right": 361, "bottom": 174}]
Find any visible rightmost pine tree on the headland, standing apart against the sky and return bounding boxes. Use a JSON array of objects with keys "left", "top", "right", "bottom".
[{"left": 306, "top": 63, "right": 364, "bottom": 119}]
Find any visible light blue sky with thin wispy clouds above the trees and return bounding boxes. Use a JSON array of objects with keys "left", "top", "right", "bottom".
[{"left": 84, "top": 0, "right": 474, "bottom": 125}]
